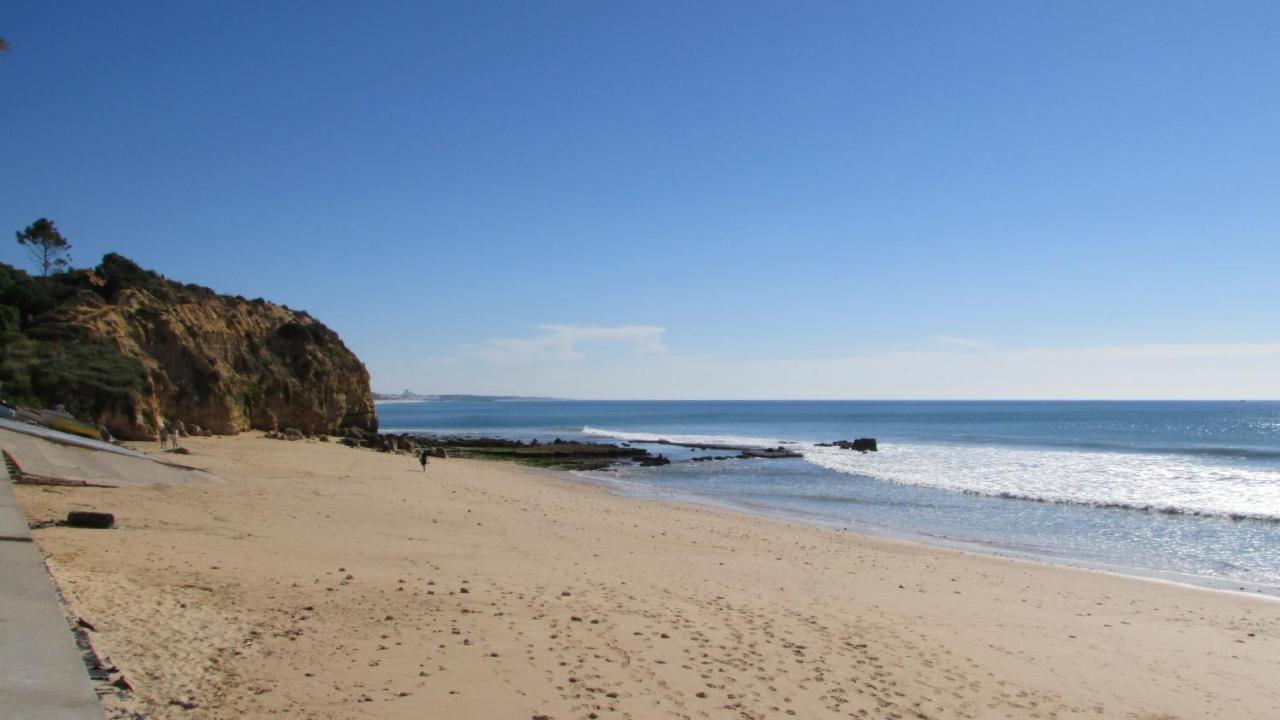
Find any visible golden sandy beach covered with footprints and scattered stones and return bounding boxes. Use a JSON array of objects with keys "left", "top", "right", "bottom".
[{"left": 17, "top": 433, "right": 1280, "bottom": 720}]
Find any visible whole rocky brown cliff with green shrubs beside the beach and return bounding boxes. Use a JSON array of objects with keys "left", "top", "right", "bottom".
[{"left": 0, "top": 254, "right": 378, "bottom": 438}]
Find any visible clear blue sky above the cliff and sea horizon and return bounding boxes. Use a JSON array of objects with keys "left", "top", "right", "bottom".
[{"left": 0, "top": 1, "right": 1280, "bottom": 398}]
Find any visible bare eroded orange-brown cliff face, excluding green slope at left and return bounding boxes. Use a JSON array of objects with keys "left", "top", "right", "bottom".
[{"left": 1, "top": 255, "right": 378, "bottom": 438}]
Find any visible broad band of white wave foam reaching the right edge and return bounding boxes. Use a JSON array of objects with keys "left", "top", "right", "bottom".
[{"left": 797, "top": 443, "right": 1280, "bottom": 520}]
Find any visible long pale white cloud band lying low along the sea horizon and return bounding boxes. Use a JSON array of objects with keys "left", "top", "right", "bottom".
[{"left": 404, "top": 338, "right": 1280, "bottom": 400}]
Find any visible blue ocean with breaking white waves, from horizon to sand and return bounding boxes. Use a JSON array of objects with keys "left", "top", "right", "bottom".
[{"left": 378, "top": 401, "right": 1280, "bottom": 596}]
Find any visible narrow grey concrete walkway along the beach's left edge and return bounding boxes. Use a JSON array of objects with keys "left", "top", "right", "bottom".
[{"left": 0, "top": 477, "right": 102, "bottom": 720}]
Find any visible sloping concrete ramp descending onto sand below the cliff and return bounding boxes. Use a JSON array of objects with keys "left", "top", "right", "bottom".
[{"left": 0, "top": 420, "right": 223, "bottom": 486}]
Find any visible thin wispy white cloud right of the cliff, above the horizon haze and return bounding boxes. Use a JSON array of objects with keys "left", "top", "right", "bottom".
[{"left": 454, "top": 325, "right": 667, "bottom": 365}]
